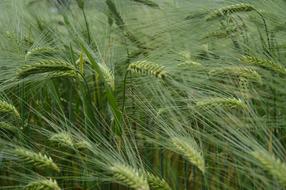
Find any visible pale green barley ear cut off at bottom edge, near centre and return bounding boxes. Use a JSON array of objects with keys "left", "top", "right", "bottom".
[{"left": 110, "top": 163, "right": 149, "bottom": 190}]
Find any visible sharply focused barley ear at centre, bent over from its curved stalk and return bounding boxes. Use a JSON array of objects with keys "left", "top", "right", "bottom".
[{"left": 128, "top": 61, "right": 168, "bottom": 79}]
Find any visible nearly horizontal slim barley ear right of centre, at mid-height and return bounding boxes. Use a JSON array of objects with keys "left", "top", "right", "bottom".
[{"left": 196, "top": 97, "right": 247, "bottom": 110}]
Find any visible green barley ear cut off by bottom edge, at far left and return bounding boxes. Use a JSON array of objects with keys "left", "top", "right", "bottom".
[{"left": 24, "top": 179, "right": 61, "bottom": 190}]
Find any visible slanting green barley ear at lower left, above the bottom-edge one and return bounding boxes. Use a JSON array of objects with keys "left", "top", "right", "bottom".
[{"left": 13, "top": 147, "right": 60, "bottom": 172}]
